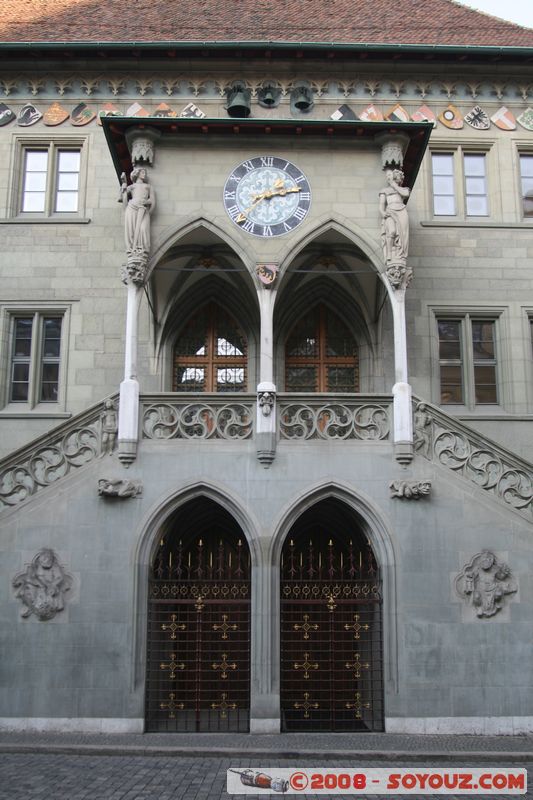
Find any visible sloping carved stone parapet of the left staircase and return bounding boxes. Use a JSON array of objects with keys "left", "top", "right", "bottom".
[{"left": 0, "top": 395, "right": 118, "bottom": 511}]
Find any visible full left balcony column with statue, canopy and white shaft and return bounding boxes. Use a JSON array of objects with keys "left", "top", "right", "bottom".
[{"left": 118, "top": 127, "right": 160, "bottom": 466}]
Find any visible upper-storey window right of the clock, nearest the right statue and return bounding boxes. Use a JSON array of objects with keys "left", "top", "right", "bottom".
[{"left": 431, "top": 150, "right": 489, "bottom": 217}]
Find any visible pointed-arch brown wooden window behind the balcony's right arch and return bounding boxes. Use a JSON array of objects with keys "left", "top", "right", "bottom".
[{"left": 285, "top": 305, "right": 359, "bottom": 392}]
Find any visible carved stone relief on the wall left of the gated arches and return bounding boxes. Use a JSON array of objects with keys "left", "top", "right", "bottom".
[{"left": 12, "top": 547, "right": 72, "bottom": 621}]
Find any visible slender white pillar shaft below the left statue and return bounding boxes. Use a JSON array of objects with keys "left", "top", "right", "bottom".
[{"left": 118, "top": 281, "right": 142, "bottom": 466}]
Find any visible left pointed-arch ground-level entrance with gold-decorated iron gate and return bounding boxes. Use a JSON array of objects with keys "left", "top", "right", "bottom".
[{"left": 146, "top": 497, "right": 251, "bottom": 732}]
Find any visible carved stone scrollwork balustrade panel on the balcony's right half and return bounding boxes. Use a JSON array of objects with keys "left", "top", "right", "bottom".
[{"left": 279, "top": 400, "right": 390, "bottom": 441}]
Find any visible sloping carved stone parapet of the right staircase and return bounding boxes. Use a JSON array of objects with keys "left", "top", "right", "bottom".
[{"left": 413, "top": 398, "right": 533, "bottom": 521}]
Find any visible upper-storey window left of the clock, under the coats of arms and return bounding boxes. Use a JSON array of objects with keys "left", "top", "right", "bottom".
[{"left": 16, "top": 142, "right": 82, "bottom": 217}]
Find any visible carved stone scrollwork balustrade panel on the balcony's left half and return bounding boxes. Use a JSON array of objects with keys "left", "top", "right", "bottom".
[{"left": 142, "top": 399, "right": 254, "bottom": 440}]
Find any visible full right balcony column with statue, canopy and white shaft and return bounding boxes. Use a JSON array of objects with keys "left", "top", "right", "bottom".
[{"left": 376, "top": 133, "right": 414, "bottom": 464}]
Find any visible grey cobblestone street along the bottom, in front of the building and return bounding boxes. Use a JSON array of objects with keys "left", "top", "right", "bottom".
[{"left": 0, "top": 753, "right": 533, "bottom": 800}]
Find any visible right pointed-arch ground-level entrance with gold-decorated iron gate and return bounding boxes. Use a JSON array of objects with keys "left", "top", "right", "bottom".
[{"left": 280, "top": 498, "right": 384, "bottom": 731}]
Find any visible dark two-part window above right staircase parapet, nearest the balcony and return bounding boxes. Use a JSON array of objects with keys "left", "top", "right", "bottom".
[{"left": 437, "top": 314, "right": 498, "bottom": 407}]
